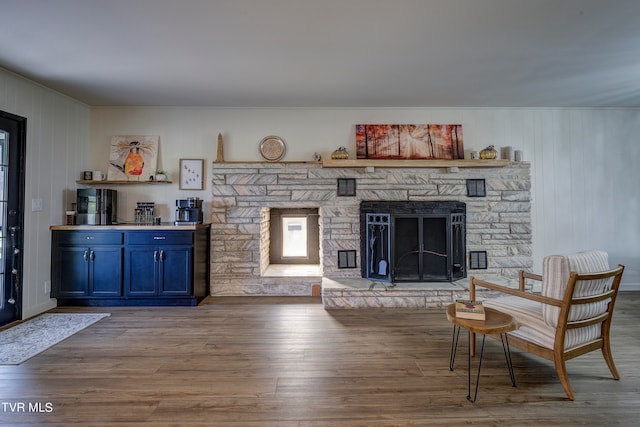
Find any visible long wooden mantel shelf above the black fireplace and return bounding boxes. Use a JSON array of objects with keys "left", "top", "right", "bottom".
[{"left": 322, "top": 159, "right": 509, "bottom": 168}]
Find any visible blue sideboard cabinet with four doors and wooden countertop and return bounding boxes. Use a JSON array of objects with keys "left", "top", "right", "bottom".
[{"left": 51, "top": 226, "right": 210, "bottom": 306}]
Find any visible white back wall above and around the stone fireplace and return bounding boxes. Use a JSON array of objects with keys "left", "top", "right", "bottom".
[{"left": 90, "top": 107, "right": 640, "bottom": 289}]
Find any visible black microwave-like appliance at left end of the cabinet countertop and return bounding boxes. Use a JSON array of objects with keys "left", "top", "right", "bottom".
[{"left": 76, "top": 188, "right": 118, "bottom": 225}]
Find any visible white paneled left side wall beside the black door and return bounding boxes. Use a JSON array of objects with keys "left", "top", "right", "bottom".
[{"left": 0, "top": 69, "right": 89, "bottom": 318}]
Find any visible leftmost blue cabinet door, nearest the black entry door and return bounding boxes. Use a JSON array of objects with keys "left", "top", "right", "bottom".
[{"left": 54, "top": 246, "right": 89, "bottom": 298}]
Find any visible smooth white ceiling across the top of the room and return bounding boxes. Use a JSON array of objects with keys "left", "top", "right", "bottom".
[{"left": 0, "top": 0, "right": 640, "bottom": 107}]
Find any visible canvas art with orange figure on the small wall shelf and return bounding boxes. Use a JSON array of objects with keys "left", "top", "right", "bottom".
[{"left": 107, "top": 135, "right": 160, "bottom": 181}]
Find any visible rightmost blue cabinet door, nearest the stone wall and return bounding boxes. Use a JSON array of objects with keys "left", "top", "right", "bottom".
[{"left": 159, "top": 246, "right": 192, "bottom": 296}]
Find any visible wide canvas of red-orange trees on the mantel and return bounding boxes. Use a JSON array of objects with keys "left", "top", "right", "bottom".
[{"left": 356, "top": 124, "right": 464, "bottom": 160}]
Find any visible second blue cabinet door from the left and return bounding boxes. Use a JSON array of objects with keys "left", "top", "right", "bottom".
[{"left": 89, "top": 247, "right": 122, "bottom": 297}]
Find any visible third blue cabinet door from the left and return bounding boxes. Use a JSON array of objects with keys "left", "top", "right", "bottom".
[{"left": 125, "top": 246, "right": 160, "bottom": 297}]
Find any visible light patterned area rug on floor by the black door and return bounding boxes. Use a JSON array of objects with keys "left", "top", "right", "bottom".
[{"left": 0, "top": 313, "right": 111, "bottom": 365}]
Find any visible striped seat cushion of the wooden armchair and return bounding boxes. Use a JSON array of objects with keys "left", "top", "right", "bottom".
[{"left": 483, "top": 295, "right": 600, "bottom": 350}]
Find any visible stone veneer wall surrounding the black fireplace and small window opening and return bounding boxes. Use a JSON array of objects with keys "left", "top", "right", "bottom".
[{"left": 211, "top": 162, "right": 533, "bottom": 295}]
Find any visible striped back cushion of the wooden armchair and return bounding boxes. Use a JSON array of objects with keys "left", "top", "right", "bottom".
[{"left": 541, "top": 251, "right": 612, "bottom": 328}]
